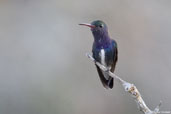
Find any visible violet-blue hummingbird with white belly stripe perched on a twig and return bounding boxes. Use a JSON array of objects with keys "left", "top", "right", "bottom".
[{"left": 79, "top": 20, "right": 118, "bottom": 89}]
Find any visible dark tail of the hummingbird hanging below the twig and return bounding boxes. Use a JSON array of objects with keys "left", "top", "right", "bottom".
[{"left": 96, "top": 65, "right": 114, "bottom": 89}]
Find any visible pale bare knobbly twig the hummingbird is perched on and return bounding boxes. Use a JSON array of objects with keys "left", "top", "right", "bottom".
[{"left": 86, "top": 54, "right": 161, "bottom": 114}]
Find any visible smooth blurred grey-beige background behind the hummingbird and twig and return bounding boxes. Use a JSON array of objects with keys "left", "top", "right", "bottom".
[{"left": 0, "top": 0, "right": 171, "bottom": 114}]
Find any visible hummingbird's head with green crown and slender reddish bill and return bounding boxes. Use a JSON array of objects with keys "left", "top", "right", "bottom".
[{"left": 79, "top": 20, "right": 108, "bottom": 38}]
